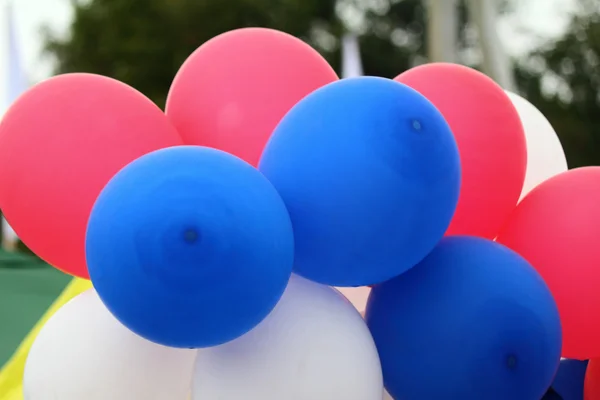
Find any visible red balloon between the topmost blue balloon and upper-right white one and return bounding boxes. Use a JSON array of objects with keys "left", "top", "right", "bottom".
[{"left": 396, "top": 63, "right": 527, "bottom": 239}]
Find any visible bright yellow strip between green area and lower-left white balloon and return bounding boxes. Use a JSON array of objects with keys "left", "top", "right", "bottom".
[{"left": 0, "top": 278, "right": 92, "bottom": 400}]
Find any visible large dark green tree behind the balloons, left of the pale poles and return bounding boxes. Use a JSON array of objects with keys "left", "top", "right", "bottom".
[{"left": 47, "top": 0, "right": 466, "bottom": 106}]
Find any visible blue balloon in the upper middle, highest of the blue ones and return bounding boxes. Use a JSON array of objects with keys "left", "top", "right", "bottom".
[{"left": 259, "top": 77, "right": 460, "bottom": 286}]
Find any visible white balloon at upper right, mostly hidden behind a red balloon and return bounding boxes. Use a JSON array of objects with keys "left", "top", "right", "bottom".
[{"left": 506, "top": 91, "right": 569, "bottom": 199}]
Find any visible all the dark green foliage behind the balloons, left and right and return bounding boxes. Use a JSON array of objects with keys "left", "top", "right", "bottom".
[{"left": 47, "top": 0, "right": 600, "bottom": 167}]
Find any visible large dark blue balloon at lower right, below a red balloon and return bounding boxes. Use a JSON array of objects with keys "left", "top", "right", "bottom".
[{"left": 366, "top": 236, "right": 562, "bottom": 400}]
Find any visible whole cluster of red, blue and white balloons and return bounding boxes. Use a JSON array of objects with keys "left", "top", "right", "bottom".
[{"left": 0, "top": 28, "right": 600, "bottom": 400}]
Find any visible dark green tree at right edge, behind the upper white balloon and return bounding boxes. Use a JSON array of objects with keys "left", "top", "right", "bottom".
[{"left": 517, "top": 0, "right": 600, "bottom": 168}]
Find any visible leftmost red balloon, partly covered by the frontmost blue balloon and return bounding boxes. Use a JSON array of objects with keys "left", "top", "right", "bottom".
[{"left": 0, "top": 74, "right": 182, "bottom": 278}]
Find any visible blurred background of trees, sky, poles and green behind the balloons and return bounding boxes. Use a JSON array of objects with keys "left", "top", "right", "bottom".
[{"left": 0, "top": 0, "right": 600, "bottom": 374}]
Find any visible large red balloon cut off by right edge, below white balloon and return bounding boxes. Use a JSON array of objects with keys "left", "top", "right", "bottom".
[{"left": 497, "top": 167, "right": 600, "bottom": 360}]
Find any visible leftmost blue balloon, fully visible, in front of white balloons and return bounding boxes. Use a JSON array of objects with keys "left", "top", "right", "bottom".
[{"left": 86, "top": 146, "right": 294, "bottom": 348}]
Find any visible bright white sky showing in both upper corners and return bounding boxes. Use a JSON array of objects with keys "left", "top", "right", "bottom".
[{"left": 0, "top": 0, "right": 574, "bottom": 99}]
